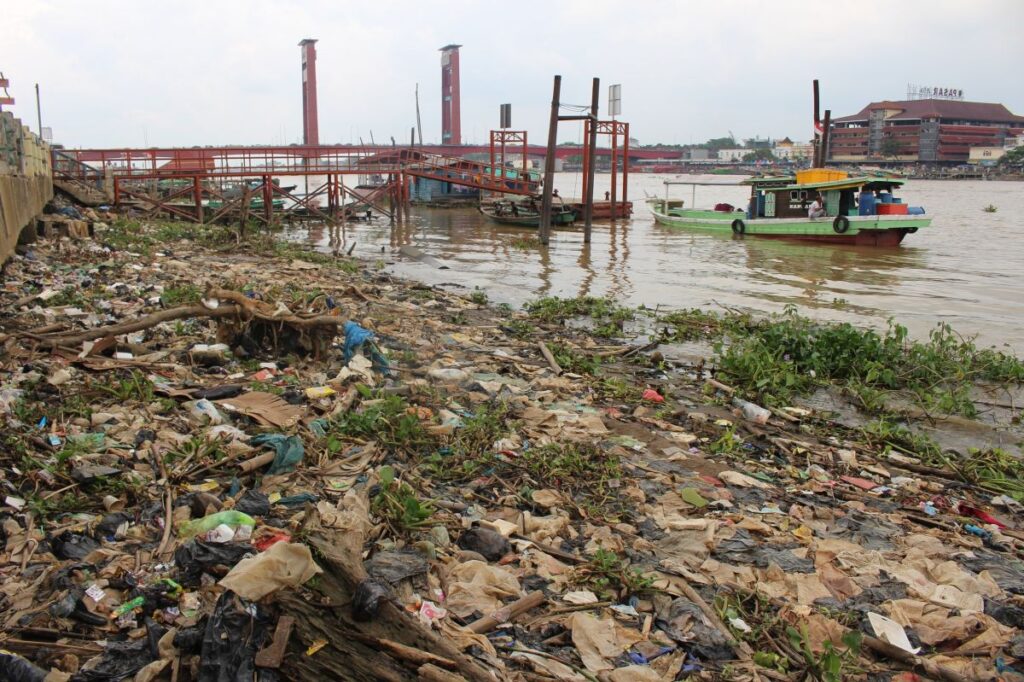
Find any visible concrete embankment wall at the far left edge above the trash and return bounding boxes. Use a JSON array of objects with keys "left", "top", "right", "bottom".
[{"left": 0, "top": 112, "right": 53, "bottom": 263}]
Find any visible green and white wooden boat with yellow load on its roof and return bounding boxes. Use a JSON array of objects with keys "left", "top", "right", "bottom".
[{"left": 647, "top": 168, "right": 932, "bottom": 246}]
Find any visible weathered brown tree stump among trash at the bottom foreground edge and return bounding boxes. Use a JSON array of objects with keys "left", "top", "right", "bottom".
[{"left": 278, "top": 505, "right": 499, "bottom": 682}]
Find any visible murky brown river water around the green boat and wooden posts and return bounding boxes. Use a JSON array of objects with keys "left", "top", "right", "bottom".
[{"left": 293, "top": 173, "right": 1024, "bottom": 355}]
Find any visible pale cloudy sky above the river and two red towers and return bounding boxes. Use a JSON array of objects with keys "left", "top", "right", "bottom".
[{"left": 0, "top": 0, "right": 1024, "bottom": 147}]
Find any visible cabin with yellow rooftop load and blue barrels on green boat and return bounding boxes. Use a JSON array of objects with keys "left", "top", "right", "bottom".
[{"left": 745, "top": 168, "right": 925, "bottom": 219}]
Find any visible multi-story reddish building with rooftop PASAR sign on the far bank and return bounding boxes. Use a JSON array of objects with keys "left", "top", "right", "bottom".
[{"left": 828, "top": 99, "right": 1024, "bottom": 164}]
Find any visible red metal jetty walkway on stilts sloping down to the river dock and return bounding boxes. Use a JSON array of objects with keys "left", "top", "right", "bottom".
[{"left": 53, "top": 145, "right": 552, "bottom": 222}]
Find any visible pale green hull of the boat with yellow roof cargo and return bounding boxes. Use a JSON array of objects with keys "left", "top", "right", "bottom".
[{"left": 651, "top": 210, "right": 932, "bottom": 246}]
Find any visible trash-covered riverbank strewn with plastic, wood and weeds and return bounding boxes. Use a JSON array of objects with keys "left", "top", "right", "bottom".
[{"left": 0, "top": 214, "right": 1024, "bottom": 682}]
